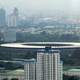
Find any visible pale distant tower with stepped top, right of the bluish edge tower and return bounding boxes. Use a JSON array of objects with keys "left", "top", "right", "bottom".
[{"left": 8, "top": 8, "right": 19, "bottom": 27}]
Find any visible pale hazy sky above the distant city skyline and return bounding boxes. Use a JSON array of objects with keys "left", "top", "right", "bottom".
[{"left": 0, "top": 0, "right": 80, "bottom": 14}]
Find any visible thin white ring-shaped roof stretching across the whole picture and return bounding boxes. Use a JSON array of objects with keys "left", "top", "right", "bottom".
[{"left": 0, "top": 42, "right": 80, "bottom": 49}]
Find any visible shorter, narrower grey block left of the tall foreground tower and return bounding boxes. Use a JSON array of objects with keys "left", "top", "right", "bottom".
[{"left": 24, "top": 59, "right": 36, "bottom": 80}]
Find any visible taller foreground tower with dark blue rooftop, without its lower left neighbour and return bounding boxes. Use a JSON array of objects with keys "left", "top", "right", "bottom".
[{"left": 36, "top": 47, "right": 62, "bottom": 80}]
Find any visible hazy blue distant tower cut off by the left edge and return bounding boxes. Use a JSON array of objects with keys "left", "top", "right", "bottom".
[{"left": 0, "top": 8, "right": 6, "bottom": 27}]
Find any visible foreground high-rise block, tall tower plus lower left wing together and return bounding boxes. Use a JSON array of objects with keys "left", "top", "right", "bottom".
[{"left": 24, "top": 47, "right": 63, "bottom": 80}]
